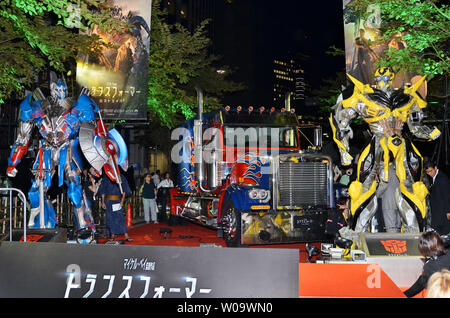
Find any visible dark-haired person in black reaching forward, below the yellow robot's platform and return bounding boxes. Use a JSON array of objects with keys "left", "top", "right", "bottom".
[{"left": 404, "top": 231, "right": 450, "bottom": 298}]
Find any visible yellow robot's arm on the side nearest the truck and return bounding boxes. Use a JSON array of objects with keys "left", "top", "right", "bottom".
[{"left": 330, "top": 97, "right": 358, "bottom": 166}]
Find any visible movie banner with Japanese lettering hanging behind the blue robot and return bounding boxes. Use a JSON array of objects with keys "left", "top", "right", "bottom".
[{"left": 77, "top": 0, "right": 152, "bottom": 120}]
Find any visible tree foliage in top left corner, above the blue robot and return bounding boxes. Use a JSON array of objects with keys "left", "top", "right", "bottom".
[{"left": 0, "top": 0, "right": 127, "bottom": 104}]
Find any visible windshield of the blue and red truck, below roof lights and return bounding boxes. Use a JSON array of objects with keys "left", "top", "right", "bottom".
[{"left": 224, "top": 126, "right": 297, "bottom": 149}]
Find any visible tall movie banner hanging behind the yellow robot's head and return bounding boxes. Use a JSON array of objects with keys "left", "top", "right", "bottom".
[{"left": 343, "top": 0, "right": 420, "bottom": 88}]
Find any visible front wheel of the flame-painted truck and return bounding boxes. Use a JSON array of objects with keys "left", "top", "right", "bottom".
[{"left": 221, "top": 201, "right": 241, "bottom": 247}]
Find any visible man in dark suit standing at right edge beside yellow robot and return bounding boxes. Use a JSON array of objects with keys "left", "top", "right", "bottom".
[{"left": 424, "top": 160, "right": 450, "bottom": 235}]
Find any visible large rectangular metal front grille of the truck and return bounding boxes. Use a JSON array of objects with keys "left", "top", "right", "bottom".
[{"left": 278, "top": 161, "right": 329, "bottom": 207}]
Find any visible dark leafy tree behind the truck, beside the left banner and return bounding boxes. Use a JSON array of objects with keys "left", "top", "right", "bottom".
[{"left": 148, "top": 0, "right": 243, "bottom": 129}]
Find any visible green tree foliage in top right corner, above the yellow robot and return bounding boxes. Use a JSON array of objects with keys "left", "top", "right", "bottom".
[{"left": 349, "top": 0, "right": 450, "bottom": 80}]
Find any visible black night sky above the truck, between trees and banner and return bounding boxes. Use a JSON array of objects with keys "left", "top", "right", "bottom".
[{"left": 213, "top": 0, "right": 345, "bottom": 106}]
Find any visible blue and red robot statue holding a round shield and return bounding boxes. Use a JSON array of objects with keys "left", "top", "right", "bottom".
[{"left": 7, "top": 72, "right": 128, "bottom": 243}]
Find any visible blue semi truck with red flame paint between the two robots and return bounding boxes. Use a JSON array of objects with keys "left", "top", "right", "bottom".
[{"left": 171, "top": 107, "right": 333, "bottom": 246}]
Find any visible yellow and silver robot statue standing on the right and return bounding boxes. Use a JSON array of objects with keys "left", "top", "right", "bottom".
[{"left": 330, "top": 67, "right": 441, "bottom": 239}]
